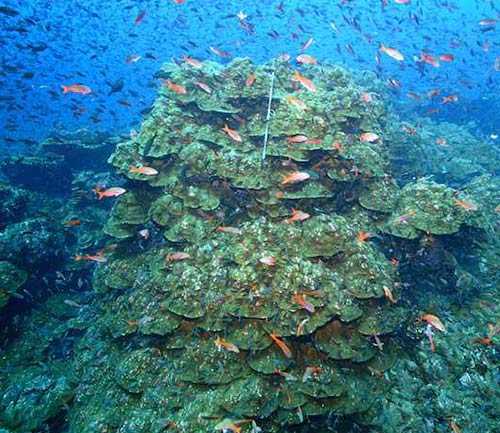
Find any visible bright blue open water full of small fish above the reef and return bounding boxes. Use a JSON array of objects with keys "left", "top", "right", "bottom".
[{"left": 0, "top": 0, "right": 500, "bottom": 151}]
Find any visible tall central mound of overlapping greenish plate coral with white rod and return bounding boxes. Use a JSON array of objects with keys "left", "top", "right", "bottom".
[{"left": 0, "top": 59, "right": 497, "bottom": 433}]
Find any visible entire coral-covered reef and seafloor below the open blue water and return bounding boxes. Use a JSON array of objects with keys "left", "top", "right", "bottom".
[{"left": 0, "top": 59, "right": 500, "bottom": 433}]
